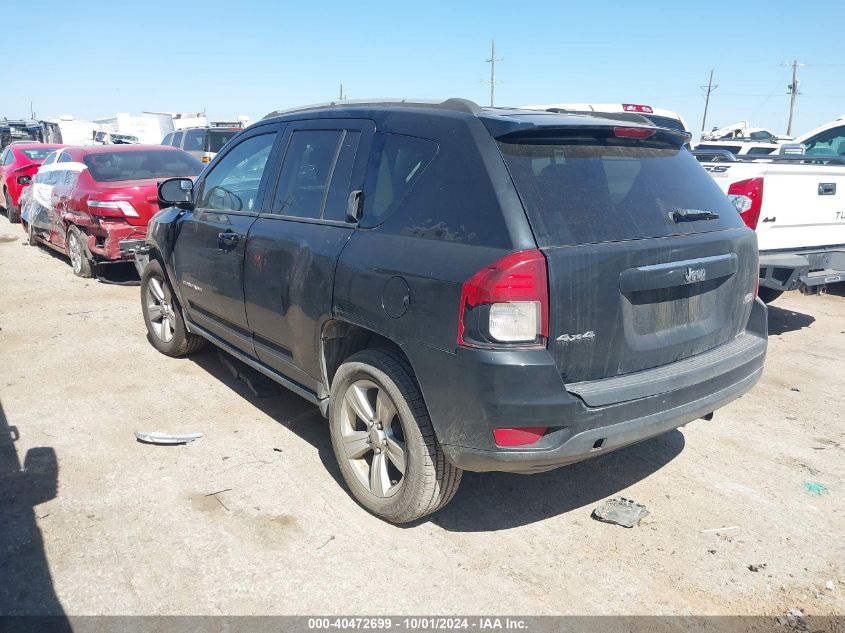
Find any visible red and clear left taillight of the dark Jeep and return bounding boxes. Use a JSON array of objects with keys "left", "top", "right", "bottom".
[{"left": 458, "top": 250, "right": 549, "bottom": 347}]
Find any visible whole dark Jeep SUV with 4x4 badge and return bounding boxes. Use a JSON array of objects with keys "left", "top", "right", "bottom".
[{"left": 138, "top": 99, "right": 767, "bottom": 522}]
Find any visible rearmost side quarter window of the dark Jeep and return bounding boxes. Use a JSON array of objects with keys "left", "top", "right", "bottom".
[{"left": 364, "top": 134, "right": 437, "bottom": 224}]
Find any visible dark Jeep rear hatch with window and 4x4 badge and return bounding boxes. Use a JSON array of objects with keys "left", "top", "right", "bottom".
[{"left": 497, "top": 125, "right": 757, "bottom": 383}]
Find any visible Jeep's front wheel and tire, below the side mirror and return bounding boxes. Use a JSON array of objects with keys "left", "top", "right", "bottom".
[{"left": 141, "top": 260, "right": 205, "bottom": 358}]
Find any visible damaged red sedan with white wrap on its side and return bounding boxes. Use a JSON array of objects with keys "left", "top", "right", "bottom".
[{"left": 21, "top": 145, "right": 203, "bottom": 277}]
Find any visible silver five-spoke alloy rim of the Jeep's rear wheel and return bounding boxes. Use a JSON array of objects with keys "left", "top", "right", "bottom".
[{"left": 341, "top": 380, "right": 407, "bottom": 498}]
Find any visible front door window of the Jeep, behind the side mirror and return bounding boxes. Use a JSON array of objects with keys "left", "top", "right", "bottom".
[{"left": 197, "top": 133, "right": 276, "bottom": 212}]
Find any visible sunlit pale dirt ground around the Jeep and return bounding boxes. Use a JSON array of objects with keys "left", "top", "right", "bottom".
[{"left": 0, "top": 219, "right": 845, "bottom": 615}]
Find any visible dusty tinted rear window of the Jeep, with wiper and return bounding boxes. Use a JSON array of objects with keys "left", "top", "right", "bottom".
[{"left": 499, "top": 138, "right": 743, "bottom": 246}]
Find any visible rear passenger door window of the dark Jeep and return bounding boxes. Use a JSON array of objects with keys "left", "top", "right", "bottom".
[{"left": 273, "top": 130, "right": 348, "bottom": 219}]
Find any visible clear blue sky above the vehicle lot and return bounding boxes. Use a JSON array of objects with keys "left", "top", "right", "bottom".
[{"left": 6, "top": 0, "right": 845, "bottom": 133}]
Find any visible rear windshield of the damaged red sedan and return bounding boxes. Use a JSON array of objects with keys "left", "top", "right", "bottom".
[{"left": 82, "top": 149, "right": 203, "bottom": 182}]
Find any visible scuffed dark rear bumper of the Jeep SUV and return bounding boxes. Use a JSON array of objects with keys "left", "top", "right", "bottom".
[{"left": 412, "top": 300, "right": 767, "bottom": 473}]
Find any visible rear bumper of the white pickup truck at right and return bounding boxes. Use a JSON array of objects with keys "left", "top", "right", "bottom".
[{"left": 760, "top": 246, "right": 845, "bottom": 292}]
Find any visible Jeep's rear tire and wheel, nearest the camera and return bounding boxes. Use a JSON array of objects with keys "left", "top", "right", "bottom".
[{"left": 329, "top": 349, "right": 462, "bottom": 523}]
